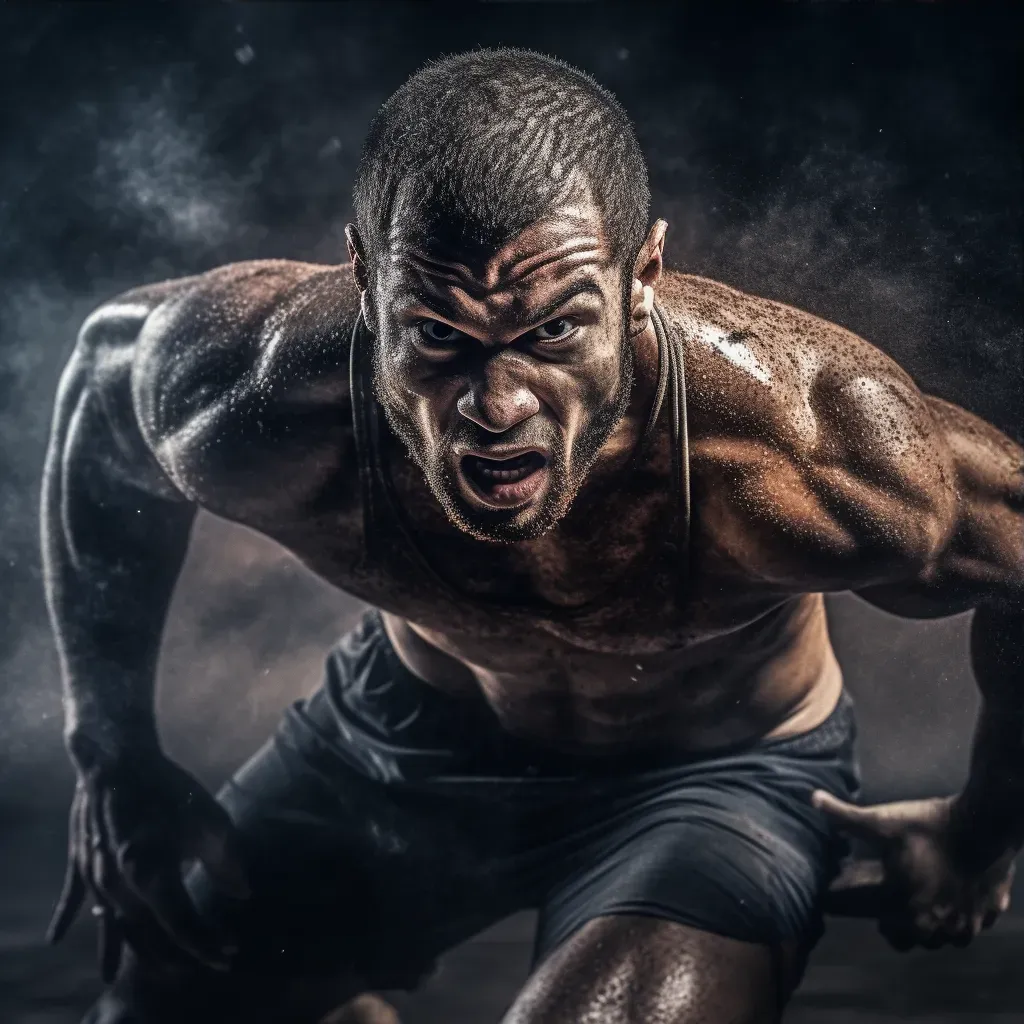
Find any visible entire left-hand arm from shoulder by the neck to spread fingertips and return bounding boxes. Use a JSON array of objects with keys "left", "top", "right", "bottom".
[{"left": 42, "top": 262, "right": 356, "bottom": 977}]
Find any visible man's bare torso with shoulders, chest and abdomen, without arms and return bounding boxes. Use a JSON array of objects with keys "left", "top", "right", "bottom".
[{"left": 86, "top": 254, "right": 999, "bottom": 752}]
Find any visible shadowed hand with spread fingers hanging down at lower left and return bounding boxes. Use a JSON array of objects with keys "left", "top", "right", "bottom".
[{"left": 47, "top": 749, "right": 248, "bottom": 982}]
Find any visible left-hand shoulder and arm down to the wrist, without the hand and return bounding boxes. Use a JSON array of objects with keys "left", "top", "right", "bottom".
[{"left": 42, "top": 261, "right": 360, "bottom": 759}]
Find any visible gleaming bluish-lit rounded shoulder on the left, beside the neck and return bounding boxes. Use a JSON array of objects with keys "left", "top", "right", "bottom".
[{"left": 76, "top": 260, "right": 358, "bottom": 504}]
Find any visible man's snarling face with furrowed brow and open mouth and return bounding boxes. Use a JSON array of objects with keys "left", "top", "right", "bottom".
[{"left": 371, "top": 193, "right": 633, "bottom": 543}]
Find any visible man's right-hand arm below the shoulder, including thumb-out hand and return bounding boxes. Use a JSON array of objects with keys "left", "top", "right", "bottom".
[{"left": 813, "top": 389, "right": 1024, "bottom": 949}]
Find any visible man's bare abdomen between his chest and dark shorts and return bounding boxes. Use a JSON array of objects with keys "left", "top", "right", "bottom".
[{"left": 383, "top": 594, "right": 843, "bottom": 756}]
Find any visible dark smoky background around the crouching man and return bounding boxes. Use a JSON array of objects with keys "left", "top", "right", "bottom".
[{"left": 0, "top": 3, "right": 1024, "bottom": 1024}]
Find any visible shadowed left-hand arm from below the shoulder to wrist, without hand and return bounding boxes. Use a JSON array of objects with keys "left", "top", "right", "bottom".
[{"left": 41, "top": 364, "right": 194, "bottom": 761}]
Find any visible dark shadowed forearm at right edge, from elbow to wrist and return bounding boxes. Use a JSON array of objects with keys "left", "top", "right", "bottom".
[{"left": 954, "top": 605, "right": 1024, "bottom": 862}]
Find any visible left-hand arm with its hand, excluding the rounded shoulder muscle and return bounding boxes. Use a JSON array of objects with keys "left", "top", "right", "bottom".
[{"left": 41, "top": 283, "right": 253, "bottom": 980}]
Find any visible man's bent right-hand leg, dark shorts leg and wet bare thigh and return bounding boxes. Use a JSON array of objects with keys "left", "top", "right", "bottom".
[{"left": 520, "top": 692, "right": 856, "bottom": 1024}]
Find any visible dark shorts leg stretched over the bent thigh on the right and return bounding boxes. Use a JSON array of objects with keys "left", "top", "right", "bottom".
[{"left": 535, "top": 737, "right": 845, "bottom": 994}]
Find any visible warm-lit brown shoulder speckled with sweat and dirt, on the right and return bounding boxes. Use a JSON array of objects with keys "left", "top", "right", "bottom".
[{"left": 665, "top": 274, "right": 956, "bottom": 583}]
